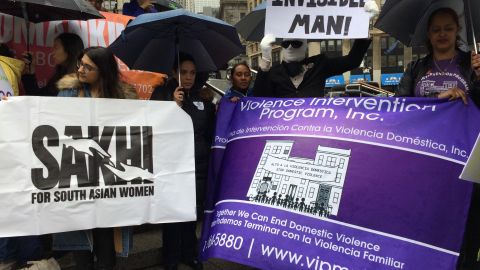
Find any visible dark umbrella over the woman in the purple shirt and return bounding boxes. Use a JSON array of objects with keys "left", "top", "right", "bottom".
[{"left": 375, "top": 0, "right": 480, "bottom": 50}]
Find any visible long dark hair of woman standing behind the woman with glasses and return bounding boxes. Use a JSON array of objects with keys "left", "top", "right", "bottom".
[{"left": 46, "top": 33, "right": 84, "bottom": 95}]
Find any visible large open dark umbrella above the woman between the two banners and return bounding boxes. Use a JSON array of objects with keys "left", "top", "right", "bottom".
[{"left": 109, "top": 9, "right": 243, "bottom": 74}]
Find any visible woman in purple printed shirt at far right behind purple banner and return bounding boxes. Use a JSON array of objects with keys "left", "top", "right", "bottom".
[{"left": 395, "top": 8, "right": 480, "bottom": 104}]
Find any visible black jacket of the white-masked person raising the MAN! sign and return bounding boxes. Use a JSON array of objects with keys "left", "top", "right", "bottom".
[{"left": 253, "top": 39, "right": 371, "bottom": 97}]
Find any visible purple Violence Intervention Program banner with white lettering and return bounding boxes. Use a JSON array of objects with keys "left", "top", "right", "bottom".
[{"left": 201, "top": 98, "right": 480, "bottom": 270}]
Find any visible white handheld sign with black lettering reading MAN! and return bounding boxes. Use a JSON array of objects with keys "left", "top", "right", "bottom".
[{"left": 265, "top": 0, "right": 370, "bottom": 39}]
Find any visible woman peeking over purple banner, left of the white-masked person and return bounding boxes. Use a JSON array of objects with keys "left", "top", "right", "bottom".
[{"left": 223, "top": 62, "right": 252, "bottom": 102}]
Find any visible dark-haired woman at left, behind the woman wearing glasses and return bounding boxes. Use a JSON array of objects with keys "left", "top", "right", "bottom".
[{"left": 22, "top": 33, "right": 84, "bottom": 96}]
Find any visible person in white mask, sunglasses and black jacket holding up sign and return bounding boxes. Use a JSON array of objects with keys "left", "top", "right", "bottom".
[{"left": 253, "top": 34, "right": 371, "bottom": 97}]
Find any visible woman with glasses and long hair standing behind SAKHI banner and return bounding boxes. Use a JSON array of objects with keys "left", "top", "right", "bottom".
[{"left": 53, "top": 47, "right": 137, "bottom": 270}]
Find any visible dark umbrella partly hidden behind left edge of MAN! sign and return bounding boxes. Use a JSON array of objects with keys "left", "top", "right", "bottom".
[{"left": 235, "top": 1, "right": 267, "bottom": 41}]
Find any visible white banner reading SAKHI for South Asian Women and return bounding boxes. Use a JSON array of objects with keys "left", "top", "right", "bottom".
[{"left": 0, "top": 97, "right": 196, "bottom": 237}]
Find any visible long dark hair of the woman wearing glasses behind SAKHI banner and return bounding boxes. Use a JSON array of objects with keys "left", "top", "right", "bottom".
[{"left": 78, "top": 47, "right": 124, "bottom": 98}]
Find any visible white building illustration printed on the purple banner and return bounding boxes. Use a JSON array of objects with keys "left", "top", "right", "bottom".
[{"left": 247, "top": 140, "right": 351, "bottom": 216}]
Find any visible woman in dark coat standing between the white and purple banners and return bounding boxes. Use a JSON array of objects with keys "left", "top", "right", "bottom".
[{"left": 150, "top": 53, "right": 215, "bottom": 270}]
